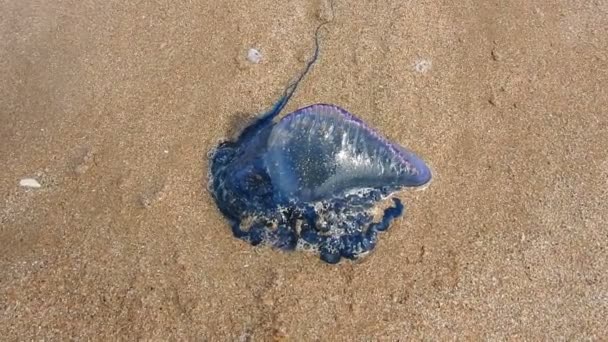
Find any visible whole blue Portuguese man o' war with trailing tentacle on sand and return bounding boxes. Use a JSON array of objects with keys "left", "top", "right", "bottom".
[{"left": 209, "top": 25, "right": 431, "bottom": 264}]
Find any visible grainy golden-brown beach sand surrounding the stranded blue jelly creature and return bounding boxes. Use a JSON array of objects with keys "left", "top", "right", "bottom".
[{"left": 0, "top": 0, "right": 608, "bottom": 341}]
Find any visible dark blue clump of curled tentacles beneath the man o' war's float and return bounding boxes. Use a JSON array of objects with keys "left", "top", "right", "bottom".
[{"left": 211, "top": 145, "right": 404, "bottom": 263}]
